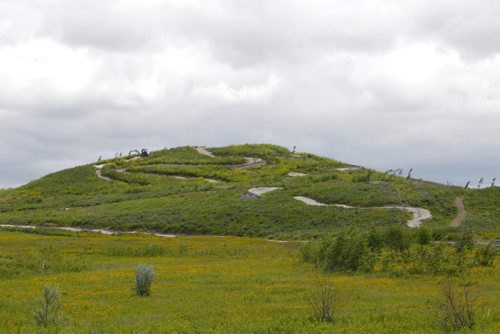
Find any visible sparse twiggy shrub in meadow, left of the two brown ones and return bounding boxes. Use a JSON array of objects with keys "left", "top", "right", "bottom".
[{"left": 309, "top": 272, "right": 341, "bottom": 322}]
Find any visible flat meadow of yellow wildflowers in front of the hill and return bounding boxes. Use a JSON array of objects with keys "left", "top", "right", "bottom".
[{"left": 0, "top": 230, "right": 500, "bottom": 333}]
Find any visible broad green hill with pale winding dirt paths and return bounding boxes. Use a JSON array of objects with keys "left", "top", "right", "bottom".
[{"left": 0, "top": 144, "right": 500, "bottom": 239}]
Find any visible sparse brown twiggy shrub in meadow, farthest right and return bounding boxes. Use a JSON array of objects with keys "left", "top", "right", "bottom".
[{"left": 439, "top": 278, "right": 479, "bottom": 330}]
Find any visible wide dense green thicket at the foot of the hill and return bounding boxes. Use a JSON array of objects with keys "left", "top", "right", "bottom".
[{"left": 301, "top": 228, "right": 480, "bottom": 276}]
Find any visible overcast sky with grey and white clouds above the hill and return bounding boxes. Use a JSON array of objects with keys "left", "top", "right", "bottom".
[{"left": 0, "top": 0, "right": 500, "bottom": 187}]
